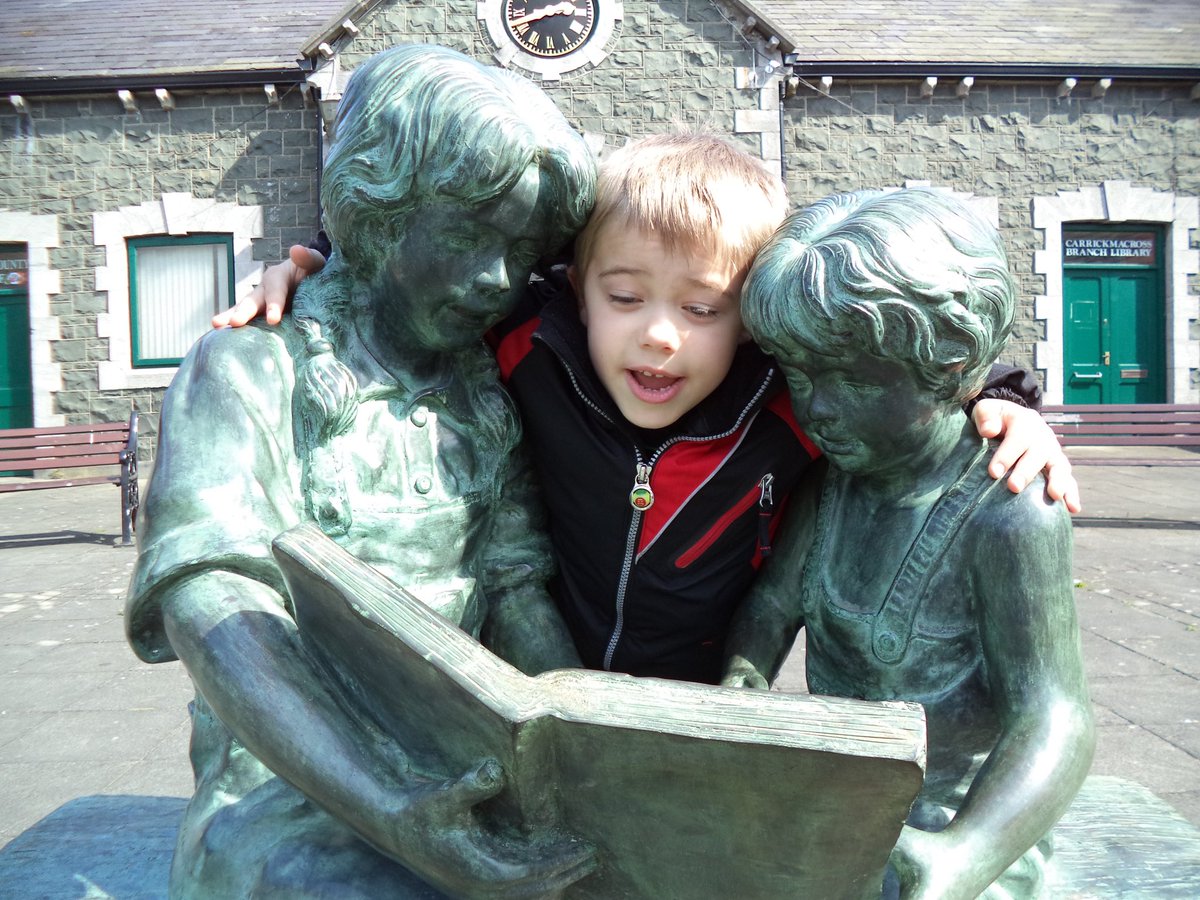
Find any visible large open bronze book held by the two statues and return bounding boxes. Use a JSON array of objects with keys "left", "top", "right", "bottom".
[{"left": 275, "top": 526, "right": 925, "bottom": 900}]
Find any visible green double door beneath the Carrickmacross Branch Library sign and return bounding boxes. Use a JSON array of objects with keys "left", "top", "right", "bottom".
[{"left": 1063, "top": 230, "right": 1166, "bottom": 403}]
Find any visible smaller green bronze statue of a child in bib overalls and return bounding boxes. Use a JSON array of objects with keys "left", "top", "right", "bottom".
[{"left": 725, "top": 190, "right": 1094, "bottom": 898}]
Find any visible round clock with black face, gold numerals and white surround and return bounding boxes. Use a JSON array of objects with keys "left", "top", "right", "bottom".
[{"left": 475, "top": 0, "right": 624, "bottom": 82}]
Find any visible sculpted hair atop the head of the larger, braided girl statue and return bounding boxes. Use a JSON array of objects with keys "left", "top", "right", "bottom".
[{"left": 322, "top": 44, "right": 595, "bottom": 274}]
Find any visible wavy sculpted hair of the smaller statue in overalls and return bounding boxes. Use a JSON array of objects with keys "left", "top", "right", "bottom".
[{"left": 742, "top": 187, "right": 1016, "bottom": 403}]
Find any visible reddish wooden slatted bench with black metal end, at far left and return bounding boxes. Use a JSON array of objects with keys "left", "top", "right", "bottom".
[{"left": 0, "top": 412, "right": 138, "bottom": 546}]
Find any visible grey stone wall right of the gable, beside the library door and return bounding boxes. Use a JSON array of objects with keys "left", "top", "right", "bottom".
[{"left": 785, "top": 79, "right": 1200, "bottom": 366}]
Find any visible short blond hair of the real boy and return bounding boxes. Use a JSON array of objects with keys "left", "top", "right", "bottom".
[{"left": 575, "top": 132, "right": 787, "bottom": 278}]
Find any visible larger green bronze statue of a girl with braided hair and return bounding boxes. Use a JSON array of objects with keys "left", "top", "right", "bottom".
[{"left": 126, "top": 47, "right": 595, "bottom": 898}]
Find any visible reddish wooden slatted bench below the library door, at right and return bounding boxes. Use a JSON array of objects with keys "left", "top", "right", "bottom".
[{"left": 1042, "top": 403, "right": 1200, "bottom": 466}]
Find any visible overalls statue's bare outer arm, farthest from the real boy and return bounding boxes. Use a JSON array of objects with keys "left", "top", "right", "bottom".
[{"left": 893, "top": 496, "right": 1096, "bottom": 898}]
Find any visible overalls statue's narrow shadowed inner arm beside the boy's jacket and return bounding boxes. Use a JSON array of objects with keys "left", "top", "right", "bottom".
[{"left": 721, "top": 467, "right": 823, "bottom": 689}]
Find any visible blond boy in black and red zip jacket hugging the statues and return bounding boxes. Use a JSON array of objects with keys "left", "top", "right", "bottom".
[{"left": 217, "top": 134, "right": 1074, "bottom": 683}]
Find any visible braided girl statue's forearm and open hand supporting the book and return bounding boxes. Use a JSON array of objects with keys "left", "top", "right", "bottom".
[{"left": 162, "top": 571, "right": 592, "bottom": 898}]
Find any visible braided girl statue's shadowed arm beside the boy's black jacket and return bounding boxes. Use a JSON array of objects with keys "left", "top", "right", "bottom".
[{"left": 481, "top": 448, "right": 583, "bottom": 674}]
